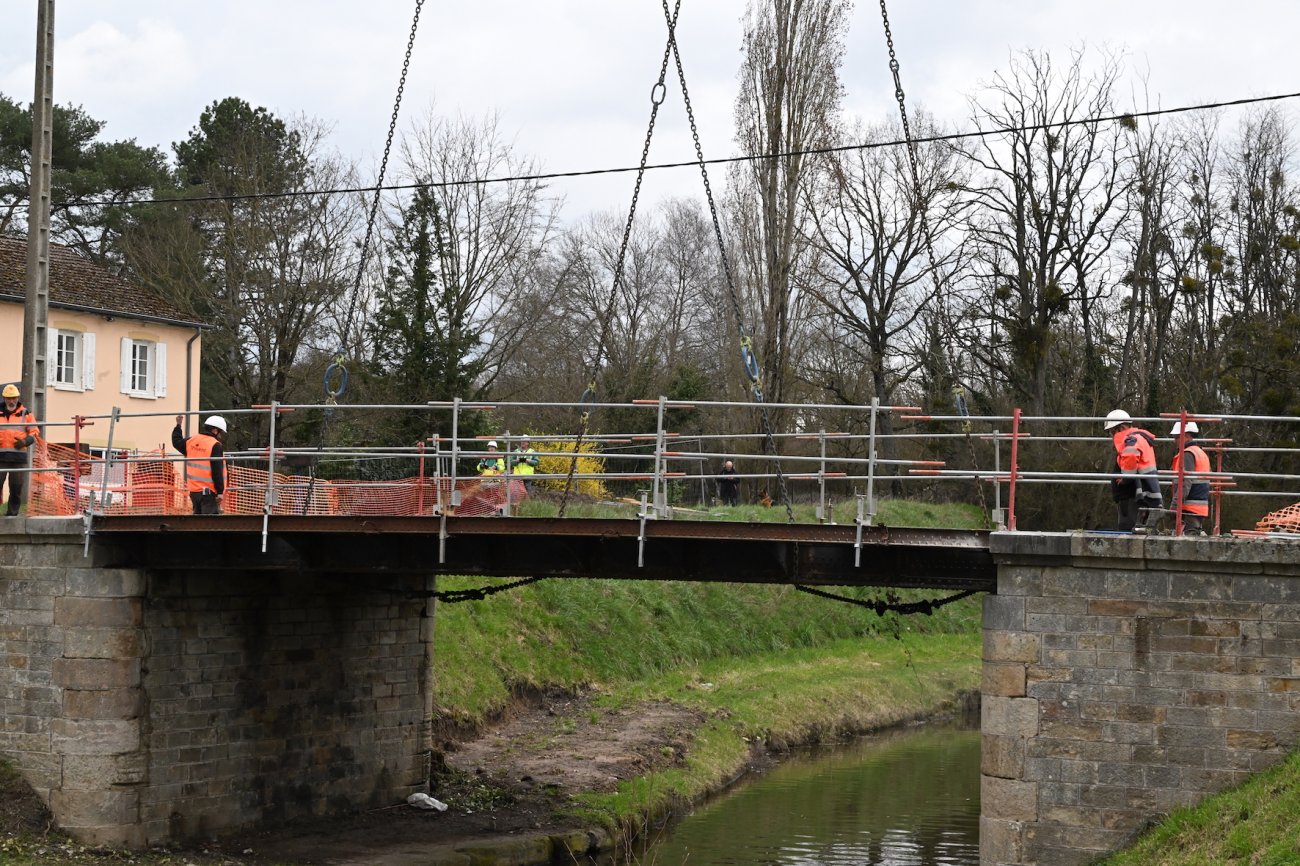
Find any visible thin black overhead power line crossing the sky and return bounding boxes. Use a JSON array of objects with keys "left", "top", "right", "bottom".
[{"left": 10, "top": 92, "right": 1300, "bottom": 209}]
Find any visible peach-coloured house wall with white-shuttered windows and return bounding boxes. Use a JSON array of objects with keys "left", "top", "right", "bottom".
[{"left": 0, "top": 303, "right": 203, "bottom": 451}]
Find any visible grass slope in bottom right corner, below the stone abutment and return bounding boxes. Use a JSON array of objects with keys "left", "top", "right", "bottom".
[{"left": 1099, "top": 753, "right": 1300, "bottom": 866}]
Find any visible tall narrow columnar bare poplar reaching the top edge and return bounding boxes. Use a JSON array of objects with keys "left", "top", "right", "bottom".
[{"left": 732, "top": 0, "right": 849, "bottom": 402}]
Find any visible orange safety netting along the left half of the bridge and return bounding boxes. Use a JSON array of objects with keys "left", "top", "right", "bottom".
[{"left": 27, "top": 442, "right": 528, "bottom": 518}]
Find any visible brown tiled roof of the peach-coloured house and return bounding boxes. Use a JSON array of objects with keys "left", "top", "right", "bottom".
[{"left": 0, "top": 237, "right": 202, "bottom": 325}]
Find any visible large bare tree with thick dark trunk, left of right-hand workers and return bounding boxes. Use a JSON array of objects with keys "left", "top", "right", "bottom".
[{"left": 963, "top": 52, "right": 1126, "bottom": 412}]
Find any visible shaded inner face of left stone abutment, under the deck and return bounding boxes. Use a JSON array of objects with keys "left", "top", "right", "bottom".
[{"left": 140, "top": 571, "right": 432, "bottom": 841}]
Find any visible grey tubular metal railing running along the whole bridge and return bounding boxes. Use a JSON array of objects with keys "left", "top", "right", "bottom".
[{"left": 15, "top": 398, "right": 1300, "bottom": 531}]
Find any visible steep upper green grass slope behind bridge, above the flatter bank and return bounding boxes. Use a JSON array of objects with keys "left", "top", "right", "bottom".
[{"left": 434, "top": 491, "right": 980, "bottom": 724}]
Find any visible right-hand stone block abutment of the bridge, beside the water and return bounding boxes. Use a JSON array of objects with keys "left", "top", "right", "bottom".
[{"left": 980, "top": 533, "right": 1300, "bottom": 866}]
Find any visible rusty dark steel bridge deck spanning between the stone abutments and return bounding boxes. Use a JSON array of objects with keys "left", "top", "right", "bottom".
[{"left": 91, "top": 515, "right": 996, "bottom": 592}]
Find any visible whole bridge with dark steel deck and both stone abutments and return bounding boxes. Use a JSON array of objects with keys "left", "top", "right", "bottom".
[{"left": 0, "top": 400, "right": 1300, "bottom": 866}]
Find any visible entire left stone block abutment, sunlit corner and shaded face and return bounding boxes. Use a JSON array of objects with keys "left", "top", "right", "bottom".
[{"left": 0, "top": 519, "right": 433, "bottom": 846}]
